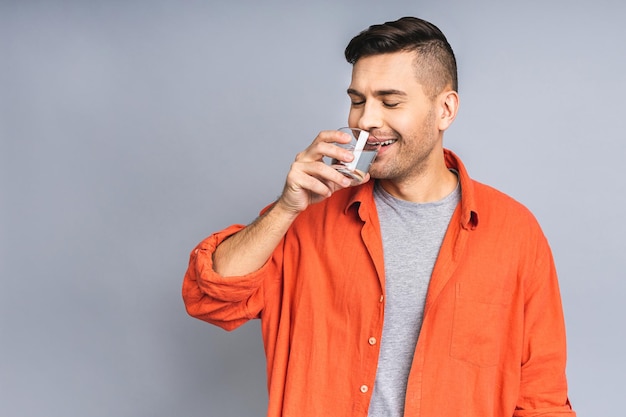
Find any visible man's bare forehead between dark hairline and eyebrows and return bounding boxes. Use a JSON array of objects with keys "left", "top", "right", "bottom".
[{"left": 350, "top": 52, "right": 421, "bottom": 94}]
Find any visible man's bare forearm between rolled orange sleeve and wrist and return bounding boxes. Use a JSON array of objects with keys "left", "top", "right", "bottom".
[{"left": 213, "top": 201, "right": 298, "bottom": 277}]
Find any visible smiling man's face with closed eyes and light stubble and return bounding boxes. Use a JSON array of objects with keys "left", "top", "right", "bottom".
[{"left": 348, "top": 52, "right": 443, "bottom": 182}]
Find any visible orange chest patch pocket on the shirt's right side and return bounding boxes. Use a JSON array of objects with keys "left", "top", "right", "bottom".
[{"left": 450, "top": 282, "right": 511, "bottom": 367}]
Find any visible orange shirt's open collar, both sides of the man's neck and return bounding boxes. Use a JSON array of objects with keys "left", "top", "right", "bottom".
[{"left": 344, "top": 149, "right": 478, "bottom": 230}]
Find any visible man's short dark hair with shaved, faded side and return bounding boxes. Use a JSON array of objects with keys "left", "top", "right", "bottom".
[{"left": 345, "top": 17, "right": 459, "bottom": 97}]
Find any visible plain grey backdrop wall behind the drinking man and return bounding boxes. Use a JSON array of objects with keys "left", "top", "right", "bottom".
[{"left": 0, "top": 0, "right": 626, "bottom": 417}]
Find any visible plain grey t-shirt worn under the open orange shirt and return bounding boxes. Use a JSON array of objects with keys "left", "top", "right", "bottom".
[{"left": 368, "top": 179, "right": 461, "bottom": 417}]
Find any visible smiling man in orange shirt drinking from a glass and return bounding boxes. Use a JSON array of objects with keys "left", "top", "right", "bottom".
[{"left": 183, "top": 14, "right": 575, "bottom": 417}]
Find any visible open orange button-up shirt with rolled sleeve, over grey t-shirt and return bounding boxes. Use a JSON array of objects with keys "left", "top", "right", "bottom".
[{"left": 183, "top": 150, "right": 575, "bottom": 417}]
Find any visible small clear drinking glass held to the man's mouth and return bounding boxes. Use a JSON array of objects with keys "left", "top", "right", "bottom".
[{"left": 330, "top": 127, "right": 380, "bottom": 182}]
